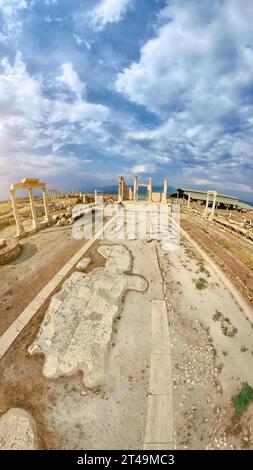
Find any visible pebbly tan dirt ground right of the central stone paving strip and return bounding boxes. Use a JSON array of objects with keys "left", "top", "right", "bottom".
[{"left": 158, "top": 233, "right": 253, "bottom": 449}]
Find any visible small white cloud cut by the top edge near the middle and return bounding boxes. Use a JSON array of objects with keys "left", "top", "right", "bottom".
[{"left": 88, "top": 0, "right": 133, "bottom": 30}]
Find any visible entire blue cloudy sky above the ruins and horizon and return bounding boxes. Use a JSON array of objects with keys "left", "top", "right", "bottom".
[{"left": 0, "top": 0, "right": 253, "bottom": 200}]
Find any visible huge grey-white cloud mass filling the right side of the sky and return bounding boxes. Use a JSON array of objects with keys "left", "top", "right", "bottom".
[{"left": 115, "top": 0, "right": 253, "bottom": 191}]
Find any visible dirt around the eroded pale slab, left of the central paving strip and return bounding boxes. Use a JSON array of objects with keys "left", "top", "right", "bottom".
[{"left": 0, "top": 242, "right": 154, "bottom": 449}]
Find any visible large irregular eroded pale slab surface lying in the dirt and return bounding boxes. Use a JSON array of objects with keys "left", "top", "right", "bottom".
[{"left": 29, "top": 245, "right": 147, "bottom": 388}]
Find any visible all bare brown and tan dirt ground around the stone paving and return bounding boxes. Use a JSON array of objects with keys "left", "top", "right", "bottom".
[{"left": 0, "top": 207, "right": 253, "bottom": 449}]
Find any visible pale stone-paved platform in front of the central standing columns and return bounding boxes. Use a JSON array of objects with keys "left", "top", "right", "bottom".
[{"left": 72, "top": 196, "right": 180, "bottom": 250}]
